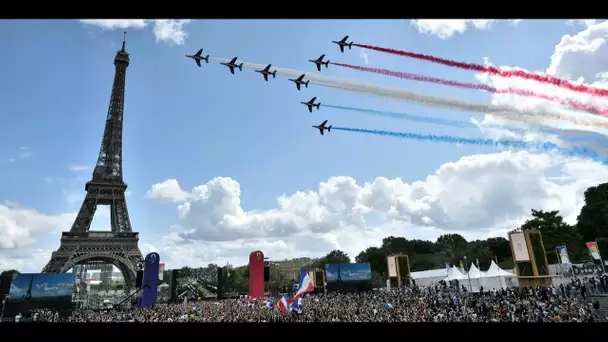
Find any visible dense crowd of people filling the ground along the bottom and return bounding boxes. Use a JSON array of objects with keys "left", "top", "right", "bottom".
[{"left": 8, "top": 278, "right": 608, "bottom": 322}]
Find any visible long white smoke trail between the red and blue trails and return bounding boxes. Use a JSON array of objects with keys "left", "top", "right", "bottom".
[{"left": 210, "top": 57, "right": 608, "bottom": 128}]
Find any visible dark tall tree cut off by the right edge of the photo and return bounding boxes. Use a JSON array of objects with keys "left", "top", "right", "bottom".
[{"left": 577, "top": 183, "right": 608, "bottom": 242}]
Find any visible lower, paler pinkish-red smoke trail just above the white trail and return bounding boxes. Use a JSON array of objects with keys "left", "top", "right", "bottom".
[{"left": 330, "top": 62, "right": 608, "bottom": 115}]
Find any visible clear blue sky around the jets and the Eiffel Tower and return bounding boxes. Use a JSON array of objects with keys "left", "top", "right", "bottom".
[{"left": 0, "top": 20, "right": 604, "bottom": 272}]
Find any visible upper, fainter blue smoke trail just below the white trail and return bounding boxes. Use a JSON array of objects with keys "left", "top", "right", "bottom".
[{"left": 322, "top": 104, "right": 607, "bottom": 145}]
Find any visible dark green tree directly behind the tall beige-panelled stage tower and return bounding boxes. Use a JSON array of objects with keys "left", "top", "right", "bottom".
[{"left": 521, "top": 209, "right": 584, "bottom": 264}]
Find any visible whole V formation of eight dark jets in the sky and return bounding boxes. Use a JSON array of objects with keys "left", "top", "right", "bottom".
[{"left": 186, "top": 36, "right": 354, "bottom": 135}]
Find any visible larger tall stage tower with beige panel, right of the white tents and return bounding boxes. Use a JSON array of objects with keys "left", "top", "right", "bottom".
[{"left": 509, "top": 230, "right": 551, "bottom": 287}]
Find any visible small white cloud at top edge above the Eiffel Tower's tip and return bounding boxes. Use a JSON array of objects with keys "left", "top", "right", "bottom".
[{"left": 80, "top": 19, "right": 191, "bottom": 45}]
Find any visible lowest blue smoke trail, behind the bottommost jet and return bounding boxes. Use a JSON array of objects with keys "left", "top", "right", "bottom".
[{"left": 332, "top": 126, "right": 608, "bottom": 164}]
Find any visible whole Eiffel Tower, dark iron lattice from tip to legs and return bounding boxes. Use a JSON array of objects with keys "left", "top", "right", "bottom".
[{"left": 42, "top": 32, "right": 142, "bottom": 289}]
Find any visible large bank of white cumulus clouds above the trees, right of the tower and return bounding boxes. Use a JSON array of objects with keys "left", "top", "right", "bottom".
[{"left": 149, "top": 151, "right": 608, "bottom": 264}]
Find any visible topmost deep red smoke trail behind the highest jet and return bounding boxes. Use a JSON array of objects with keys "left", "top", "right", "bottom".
[{"left": 353, "top": 44, "right": 608, "bottom": 96}]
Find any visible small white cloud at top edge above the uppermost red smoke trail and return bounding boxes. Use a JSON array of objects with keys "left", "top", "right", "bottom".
[{"left": 410, "top": 19, "right": 521, "bottom": 39}]
